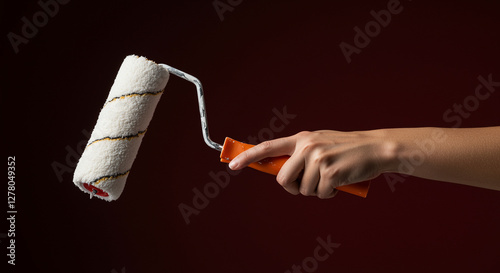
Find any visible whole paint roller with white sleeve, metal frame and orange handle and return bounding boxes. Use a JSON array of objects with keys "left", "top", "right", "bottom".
[{"left": 73, "top": 55, "right": 369, "bottom": 201}]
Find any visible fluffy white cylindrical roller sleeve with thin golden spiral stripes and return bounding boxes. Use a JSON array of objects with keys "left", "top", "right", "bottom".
[{"left": 73, "top": 55, "right": 169, "bottom": 201}]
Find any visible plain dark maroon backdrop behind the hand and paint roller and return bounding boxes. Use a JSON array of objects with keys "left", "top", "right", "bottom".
[{"left": 0, "top": 0, "right": 500, "bottom": 273}]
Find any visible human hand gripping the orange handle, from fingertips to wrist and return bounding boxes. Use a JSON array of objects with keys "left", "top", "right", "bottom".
[{"left": 229, "top": 130, "right": 394, "bottom": 198}]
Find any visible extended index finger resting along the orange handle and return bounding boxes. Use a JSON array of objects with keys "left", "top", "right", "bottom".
[{"left": 229, "top": 137, "right": 295, "bottom": 170}]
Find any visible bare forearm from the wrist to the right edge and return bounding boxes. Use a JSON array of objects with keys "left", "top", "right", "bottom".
[{"left": 378, "top": 127, "right": 500, "bottom": 190}]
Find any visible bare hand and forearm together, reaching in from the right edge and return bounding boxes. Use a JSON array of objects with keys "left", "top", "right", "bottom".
[{"left": 229, "top": 126, "right": 500, "bottom": 198}]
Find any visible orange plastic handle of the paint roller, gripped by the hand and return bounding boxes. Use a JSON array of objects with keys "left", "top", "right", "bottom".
[{"left": 220, "top": 137, "right": 370, "bottom": 198}]
